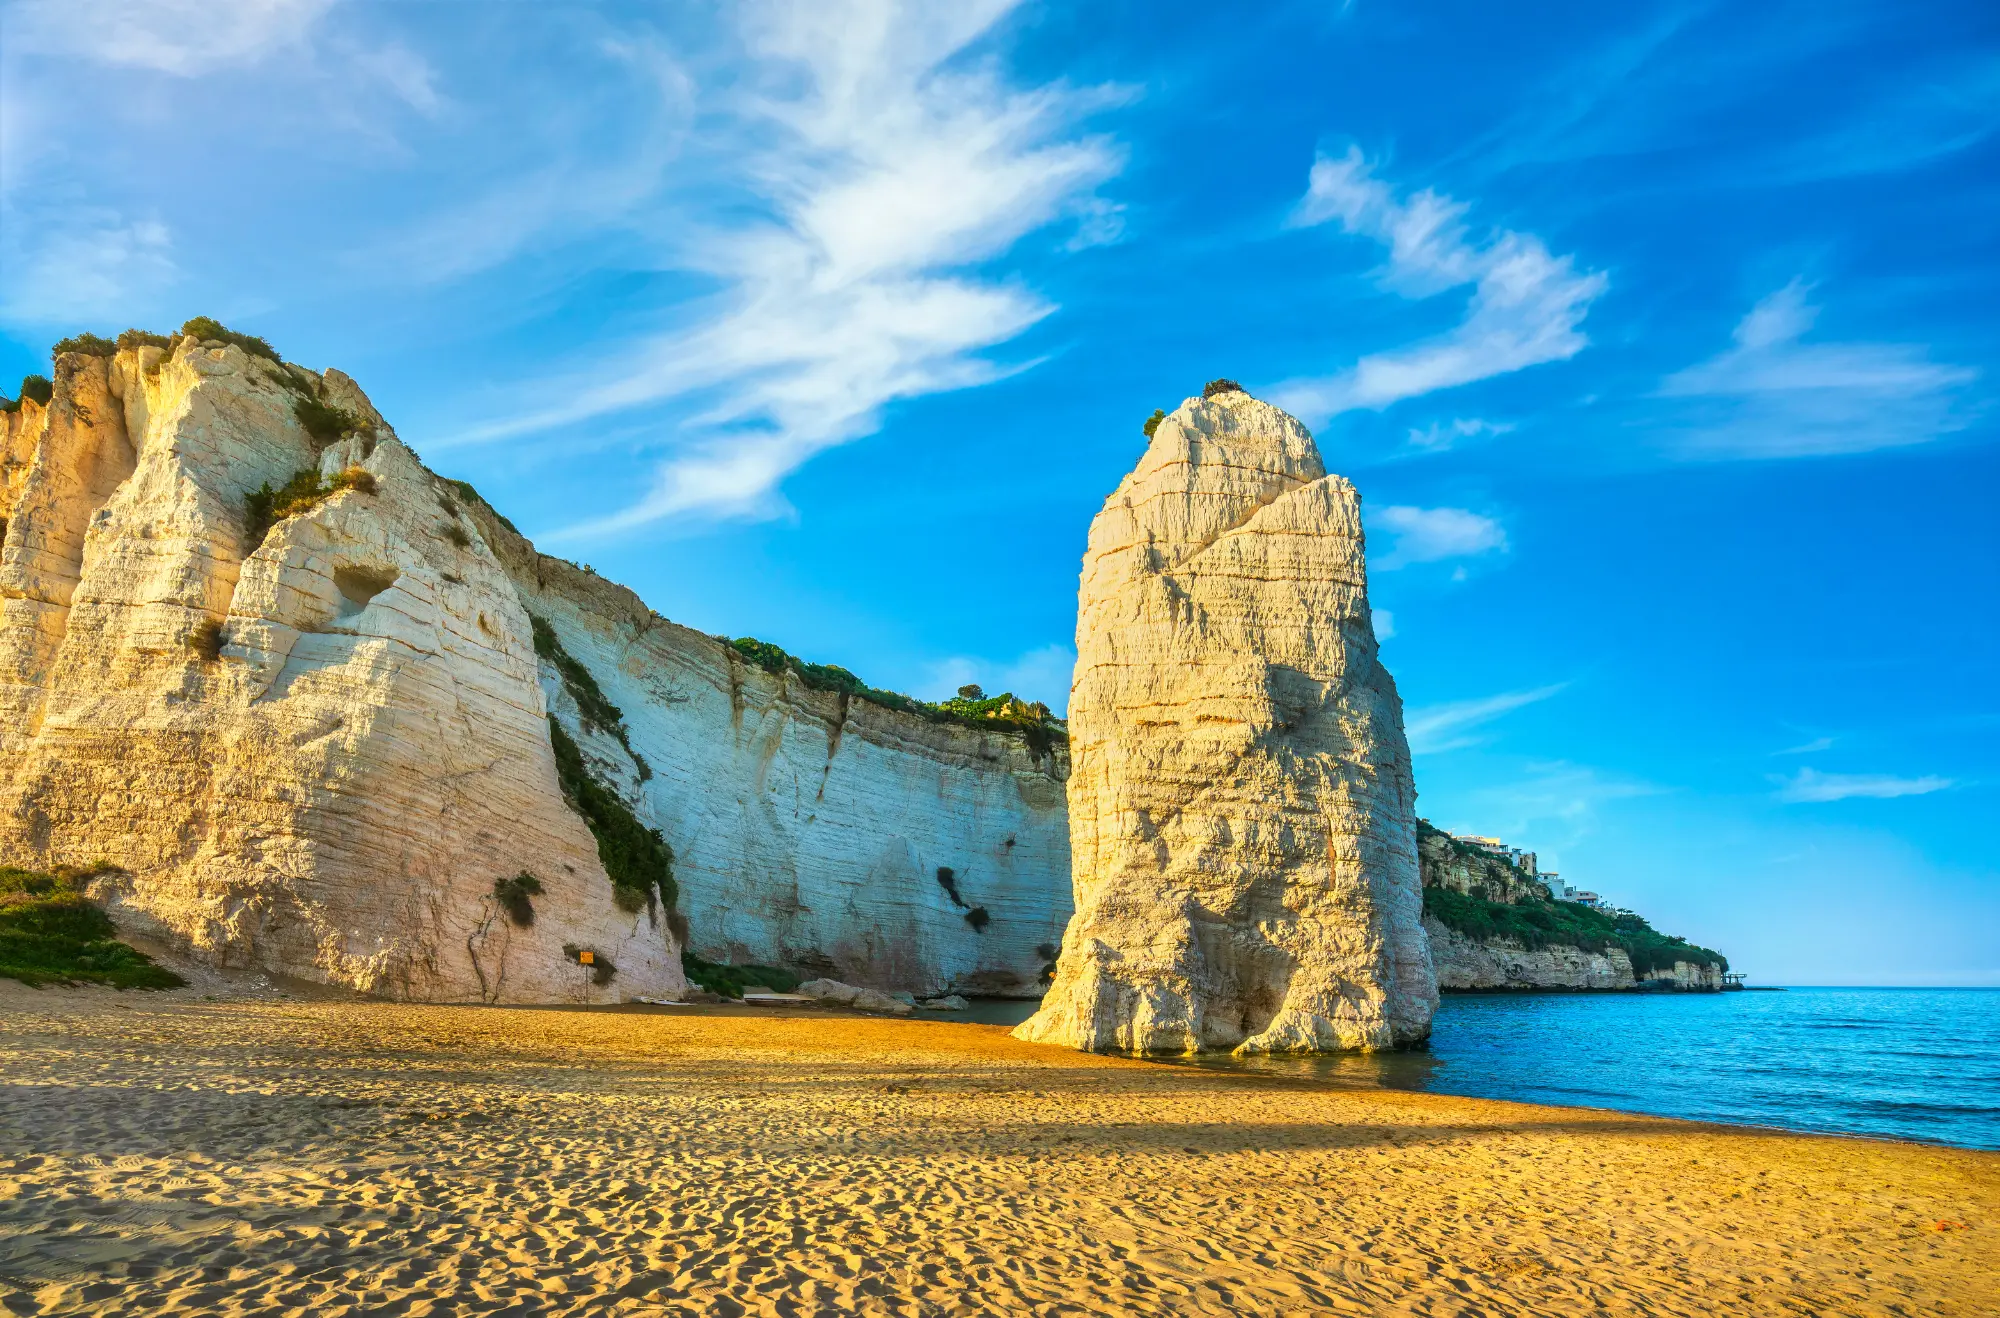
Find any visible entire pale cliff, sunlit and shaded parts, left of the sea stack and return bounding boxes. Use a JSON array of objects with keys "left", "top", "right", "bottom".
[{"left": 0, "top": 338, "right": 1068, "bottom": 1002}]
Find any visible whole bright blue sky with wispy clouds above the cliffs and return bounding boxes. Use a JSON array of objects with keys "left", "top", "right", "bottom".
[{"left": 0, "top": 0, "right": 2000, "bottom": 984}]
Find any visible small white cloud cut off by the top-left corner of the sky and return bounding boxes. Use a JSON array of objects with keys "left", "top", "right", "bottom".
[{"left": 6, "top": 0, "right": 336, "bottom": 78}]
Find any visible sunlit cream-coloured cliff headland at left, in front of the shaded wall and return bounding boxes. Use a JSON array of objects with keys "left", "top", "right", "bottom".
[{"left": 0, "top": 338, "right": 682, "bottom": 1002}]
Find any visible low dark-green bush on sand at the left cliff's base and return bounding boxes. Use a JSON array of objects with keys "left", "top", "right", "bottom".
[{"left": 0, "top": 866, "right": 186, "bottom": 988}]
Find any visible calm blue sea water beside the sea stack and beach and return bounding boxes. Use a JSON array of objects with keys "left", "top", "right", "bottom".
[{"left": 960, "top": 988, "right": 2000, "bottom": 1148}]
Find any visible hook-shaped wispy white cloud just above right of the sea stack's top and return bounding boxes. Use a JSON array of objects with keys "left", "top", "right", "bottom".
[{"left": 1274, "top": 148, "right": 1608, "bottom": 424}]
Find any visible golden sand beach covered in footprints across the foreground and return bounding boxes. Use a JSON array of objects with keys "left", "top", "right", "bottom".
[{"left": 0, "top": 986, "right": 2000, "bottom": 1318}]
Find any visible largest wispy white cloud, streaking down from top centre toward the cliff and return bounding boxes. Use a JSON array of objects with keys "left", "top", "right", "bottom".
[{"left": 460, "top": 0, "right": 1122, "bottom": 540}]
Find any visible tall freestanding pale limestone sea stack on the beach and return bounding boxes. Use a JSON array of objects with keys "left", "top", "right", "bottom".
[{"left": 1016, "top": 382, "right": 1438, "bottom": 1054}]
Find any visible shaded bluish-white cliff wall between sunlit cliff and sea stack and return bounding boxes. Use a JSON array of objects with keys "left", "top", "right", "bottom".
[{"left": 488, "top": 524, "right": 1070, "bottom": 996}]
